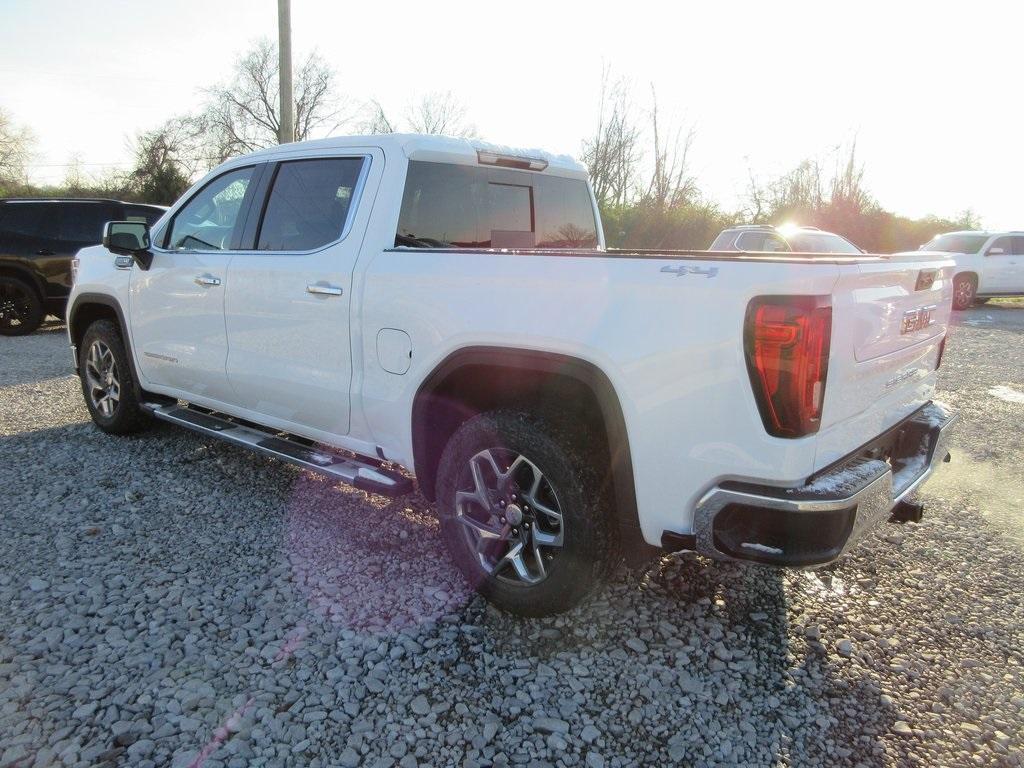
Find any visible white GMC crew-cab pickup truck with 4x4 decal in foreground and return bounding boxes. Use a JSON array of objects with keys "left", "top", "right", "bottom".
[{"left": 68, "top": 135, "right": 953, "bottom": 615}]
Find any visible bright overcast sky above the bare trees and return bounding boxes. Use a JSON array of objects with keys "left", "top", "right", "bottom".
[{"left": 0, "top": 0, "right": 1024, "bottom": 228}]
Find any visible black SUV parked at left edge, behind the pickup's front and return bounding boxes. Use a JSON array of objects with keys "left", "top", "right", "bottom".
[{"left": 0, "top": 199, "right": 164, "bottom": 336}]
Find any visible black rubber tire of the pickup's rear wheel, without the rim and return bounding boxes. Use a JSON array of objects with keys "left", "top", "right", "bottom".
[{"left": 437, "top": 411, "right": 621, "bottom": 616}]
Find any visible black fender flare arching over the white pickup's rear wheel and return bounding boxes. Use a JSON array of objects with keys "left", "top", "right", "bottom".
[{"left": 411, "top": 346, "right": 656, "bottom": 557}]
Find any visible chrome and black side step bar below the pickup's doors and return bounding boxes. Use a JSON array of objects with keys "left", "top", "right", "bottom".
[{"left": 145, "top": 402, "right": 413, "bottom": 498}]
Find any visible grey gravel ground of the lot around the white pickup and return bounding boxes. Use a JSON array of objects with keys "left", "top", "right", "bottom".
[{"left": 0, "top": 303, "right": 1024, "bottom": 768}]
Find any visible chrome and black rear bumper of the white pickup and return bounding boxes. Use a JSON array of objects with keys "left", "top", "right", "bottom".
[{"left": 684, "top": 402, "right": 958, "bottom": 566}]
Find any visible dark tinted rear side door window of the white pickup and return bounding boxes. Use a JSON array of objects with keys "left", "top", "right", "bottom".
[{"left": 256, "top": 158, "right": 366, "bottom": 251}]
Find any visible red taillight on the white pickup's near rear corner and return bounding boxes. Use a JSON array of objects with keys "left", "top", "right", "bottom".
[{"left": 743, "top": 296, "right": 831, "bottom": 437}]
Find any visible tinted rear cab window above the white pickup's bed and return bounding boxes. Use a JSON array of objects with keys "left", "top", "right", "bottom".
[{"left": 395, "top": 161, "right": 597, "bottom": 248}]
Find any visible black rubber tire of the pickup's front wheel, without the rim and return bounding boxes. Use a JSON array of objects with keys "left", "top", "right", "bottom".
[{"left": 78, "top": 319, "right": 153, "bottom": 434}]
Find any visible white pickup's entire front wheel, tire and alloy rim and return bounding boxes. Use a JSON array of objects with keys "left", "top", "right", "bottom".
[{"left": 78, "top": 319, "right": 153, "bottom": 434}]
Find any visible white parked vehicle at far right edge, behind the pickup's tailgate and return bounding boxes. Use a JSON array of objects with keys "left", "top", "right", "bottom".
[{"left": 921, "top": 231, "right": 1024, "bottom": 309}]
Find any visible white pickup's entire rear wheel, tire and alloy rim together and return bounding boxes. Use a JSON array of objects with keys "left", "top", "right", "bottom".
[{"left": 437, "top": 411, "right": 618, "bottom": 616}]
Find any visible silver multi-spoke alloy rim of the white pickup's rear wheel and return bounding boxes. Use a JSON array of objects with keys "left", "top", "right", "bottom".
[{"left": 455, "top": 449, "right": 564, "bottom": 585}]
